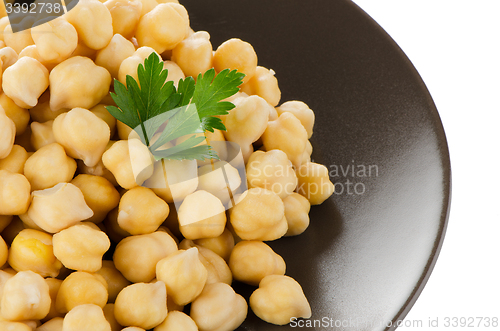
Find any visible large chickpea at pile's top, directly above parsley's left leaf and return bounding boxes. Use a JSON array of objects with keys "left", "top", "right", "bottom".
[{"left": 135, "top": 3, "right": 189, "bottom": 53}]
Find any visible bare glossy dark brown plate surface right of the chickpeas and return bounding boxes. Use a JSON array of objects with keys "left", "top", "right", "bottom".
[{"left": 182, "top": 0, "right": 451, "bottom": 331}]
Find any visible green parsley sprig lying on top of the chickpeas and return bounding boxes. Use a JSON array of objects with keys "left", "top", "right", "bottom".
[{"left": 106, "top": 53, "right": 245, "bottom": 160}]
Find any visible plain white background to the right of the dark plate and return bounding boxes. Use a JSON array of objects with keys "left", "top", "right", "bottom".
[{"left": 354, "top": 0, "right": 500, "bottom": 331}]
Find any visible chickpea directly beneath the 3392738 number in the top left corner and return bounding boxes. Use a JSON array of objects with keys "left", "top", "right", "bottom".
[{"left": 31, "top": 17, "right": 78, "bottom": 63}]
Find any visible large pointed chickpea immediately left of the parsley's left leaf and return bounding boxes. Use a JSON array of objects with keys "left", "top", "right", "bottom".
[{"left": 49, "top": 57, "right": 111, "bottom": 110}]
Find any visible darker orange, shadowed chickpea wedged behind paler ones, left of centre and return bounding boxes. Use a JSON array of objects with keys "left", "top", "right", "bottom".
[{"left": 71, "top": 174, "right": 120, "bottom": 223}]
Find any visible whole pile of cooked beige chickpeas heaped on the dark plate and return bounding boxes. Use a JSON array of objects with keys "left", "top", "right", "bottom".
[{"left": 0, "top": 0, "right": 334, "bottom": 331}]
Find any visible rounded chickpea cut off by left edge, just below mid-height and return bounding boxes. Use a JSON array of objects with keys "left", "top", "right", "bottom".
[{"left": 0, "top": 170, "right": 31, "bottom": 215}]
